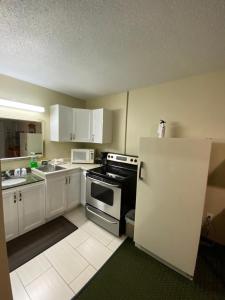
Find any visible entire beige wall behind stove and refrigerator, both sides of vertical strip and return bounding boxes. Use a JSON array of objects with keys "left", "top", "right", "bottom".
[{"left": 87, "top": 71, "right": 225, "bottom": 244}]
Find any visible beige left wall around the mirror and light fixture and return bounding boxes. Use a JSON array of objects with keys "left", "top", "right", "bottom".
[{"left": 0, "top": 75, "right": 85, "bottom": 169}]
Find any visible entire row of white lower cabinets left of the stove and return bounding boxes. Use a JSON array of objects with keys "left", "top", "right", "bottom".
[{"left": 2, "top": 169, "right": 83, "bottom": 241}]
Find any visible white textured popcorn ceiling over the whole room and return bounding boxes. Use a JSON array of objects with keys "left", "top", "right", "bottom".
[{"left": 0, "top": 0, "right": 225, "bottom": 99}]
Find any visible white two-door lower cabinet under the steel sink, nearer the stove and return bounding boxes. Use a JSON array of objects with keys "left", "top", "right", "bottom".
[{"left": 46, "top": 169, "right": 80, "bottom": 219}]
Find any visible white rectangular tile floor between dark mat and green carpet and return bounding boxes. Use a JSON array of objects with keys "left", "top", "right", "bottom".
[{"left": 10, "top": 206, "right": 125, "bottom": 300}]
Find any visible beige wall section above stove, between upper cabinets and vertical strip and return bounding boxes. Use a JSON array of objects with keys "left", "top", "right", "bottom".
[{"left": 86, "top": 93, "right": 127, "bottom": 153}]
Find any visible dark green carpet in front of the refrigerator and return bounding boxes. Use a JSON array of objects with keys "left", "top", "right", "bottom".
[{"left": 74, "top": 239, "right": 225, "bottom": 300}]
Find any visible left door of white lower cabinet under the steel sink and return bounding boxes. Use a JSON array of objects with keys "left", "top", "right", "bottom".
[{"left": 46, "top": 175, "right": 66, "bottom": 218}]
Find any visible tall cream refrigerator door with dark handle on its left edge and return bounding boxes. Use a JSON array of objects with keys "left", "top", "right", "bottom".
[{"left": 134, "top": 138, "right": 211, "bottom": 277}]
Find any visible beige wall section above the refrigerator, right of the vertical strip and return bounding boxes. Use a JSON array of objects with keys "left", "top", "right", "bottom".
[{"left": 127, "top": 72, "right": 225, "bottom": 154}]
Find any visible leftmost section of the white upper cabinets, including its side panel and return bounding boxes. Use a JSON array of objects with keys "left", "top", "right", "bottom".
[{"left": 50, "top": 104, "right": 73, "bottom": 142}]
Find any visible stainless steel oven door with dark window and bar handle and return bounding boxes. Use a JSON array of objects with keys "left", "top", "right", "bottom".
[{"left": 86, "top": 176, "right": 121, "bottom": 220}]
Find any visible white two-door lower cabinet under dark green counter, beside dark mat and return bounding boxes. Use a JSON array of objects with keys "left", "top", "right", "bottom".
[{"left": 2, "top": 183, "right": 45, "bottom": 241}]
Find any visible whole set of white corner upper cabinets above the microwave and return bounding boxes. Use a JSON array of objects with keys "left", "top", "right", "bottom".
[{"left": 50, "top": 104, "right": 112, "bottom": 144}]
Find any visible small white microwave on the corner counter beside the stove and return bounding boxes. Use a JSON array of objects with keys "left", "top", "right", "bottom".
[{"left": 71, "top": 149, "right": 95, "bottom": 164}]
